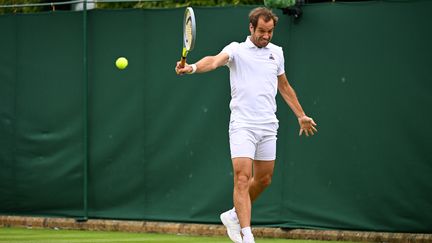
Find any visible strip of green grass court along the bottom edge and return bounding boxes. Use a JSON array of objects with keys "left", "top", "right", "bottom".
[{"left": 0, "top": 227, "right": 362, "bottom": 243}]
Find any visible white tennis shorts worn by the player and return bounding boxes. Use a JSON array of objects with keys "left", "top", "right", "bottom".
[{"left": 229, "top": 121, "right": 279, "bottom": 161}]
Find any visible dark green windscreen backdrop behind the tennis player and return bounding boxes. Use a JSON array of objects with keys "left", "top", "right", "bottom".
[{"left": 0, "top": 1, "right": 432, "bottom": 232}]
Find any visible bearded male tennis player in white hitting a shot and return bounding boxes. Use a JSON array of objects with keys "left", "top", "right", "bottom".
[{"left": 176, "top": 7, "right": 317, "bottom": 243}]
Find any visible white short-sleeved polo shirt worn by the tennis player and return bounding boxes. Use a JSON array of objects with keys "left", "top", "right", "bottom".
[{"left": 221, "top": 36, "right": 285, "bottom": 124}]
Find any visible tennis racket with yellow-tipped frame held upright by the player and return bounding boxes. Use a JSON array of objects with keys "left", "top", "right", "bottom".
[{"left": 180, "top": 7, "right": 196, "bottom": 67}]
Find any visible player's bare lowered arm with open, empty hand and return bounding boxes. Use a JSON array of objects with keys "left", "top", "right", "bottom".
[{"left": 278, "top": 73, "right": 318, "bottom": 136}]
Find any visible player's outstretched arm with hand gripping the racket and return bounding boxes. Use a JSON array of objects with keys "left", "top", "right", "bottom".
[{"left": 176, "top": 52, "right": 229, "bottom": 74}]
